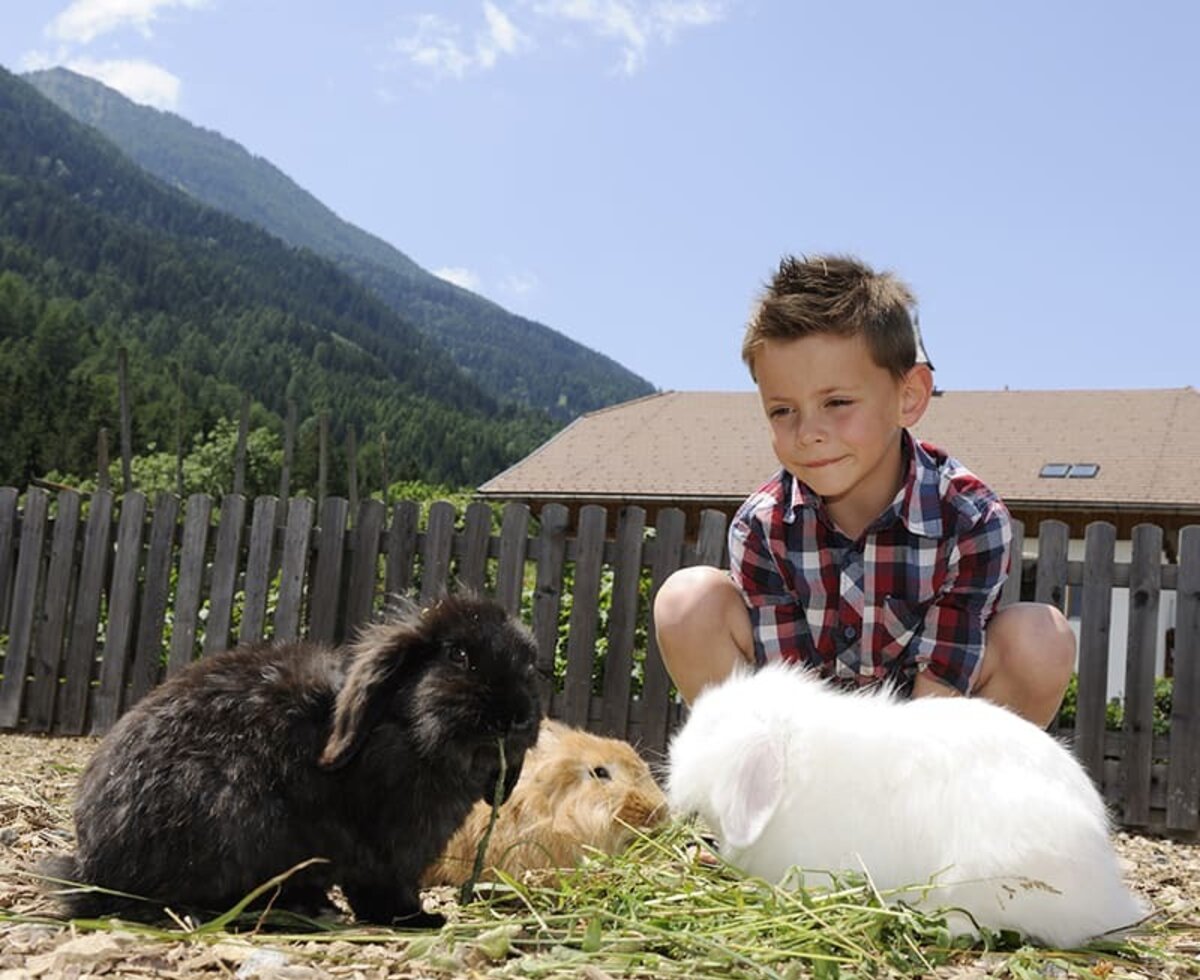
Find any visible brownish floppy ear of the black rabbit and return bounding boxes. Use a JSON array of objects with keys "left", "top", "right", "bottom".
[{"left": 318, "top": 623, "right": 415, "bottom": 769}]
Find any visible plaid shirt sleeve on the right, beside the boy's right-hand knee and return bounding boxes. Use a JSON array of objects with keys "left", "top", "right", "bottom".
[{"left": 912, "top": 501, "right": 1013, "bottom": 695}]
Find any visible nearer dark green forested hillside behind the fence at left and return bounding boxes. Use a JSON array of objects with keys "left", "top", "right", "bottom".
[{"left": 0, "top": 70, "right": 554, "bottom": 489}]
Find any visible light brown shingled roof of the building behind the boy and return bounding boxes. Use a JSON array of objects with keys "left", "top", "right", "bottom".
[{"left": 479, "top": 386, "right": 1200, "bottom": 519}]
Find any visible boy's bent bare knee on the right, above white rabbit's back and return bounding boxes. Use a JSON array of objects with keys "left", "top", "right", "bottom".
[{"left": 971, "top": 602, "right": 1075, "bottom": 728}]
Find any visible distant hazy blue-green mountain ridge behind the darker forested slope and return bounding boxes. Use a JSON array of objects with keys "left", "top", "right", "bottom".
[{"left": 24, "top": 68, "right": 654, "bottom": 421}]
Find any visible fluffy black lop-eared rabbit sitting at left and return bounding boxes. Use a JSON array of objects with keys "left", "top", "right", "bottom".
[{"left": 47, "top": 587, "right": 541, "bottom": 926}]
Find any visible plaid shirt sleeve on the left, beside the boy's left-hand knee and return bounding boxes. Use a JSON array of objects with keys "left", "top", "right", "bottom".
[{"left": 730, "top": 503, "right": 808, "bottom": 665}]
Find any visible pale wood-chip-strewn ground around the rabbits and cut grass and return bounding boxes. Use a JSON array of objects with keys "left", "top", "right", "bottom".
[{"left": 0, "top": 735, "right": 1200, "bottom": 980}]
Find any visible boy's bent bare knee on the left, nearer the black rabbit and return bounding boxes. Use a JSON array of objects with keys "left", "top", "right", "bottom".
[{"left": 654, "top": 565, "right": 754, "bottom": 704}]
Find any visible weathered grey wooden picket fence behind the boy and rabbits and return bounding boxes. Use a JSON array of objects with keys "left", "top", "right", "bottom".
[{"left": 0, "top": 488, "right": 1200, "bottom": 836}]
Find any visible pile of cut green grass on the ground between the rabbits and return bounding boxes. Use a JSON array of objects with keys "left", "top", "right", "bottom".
[{"left": 11, "top": 824, "right": 1195, "bottom": 980}]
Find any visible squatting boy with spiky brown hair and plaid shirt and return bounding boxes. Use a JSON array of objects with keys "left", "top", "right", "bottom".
[{"left": 654, "top": 257, "right": 1075, "bottom": 727}]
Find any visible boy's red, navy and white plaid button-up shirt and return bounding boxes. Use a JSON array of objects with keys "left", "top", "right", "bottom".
[{"left": 730, "top": 431, "right": 1013, "bottom": 693}]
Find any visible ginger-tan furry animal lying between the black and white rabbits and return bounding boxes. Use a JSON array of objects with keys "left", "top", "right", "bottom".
[{"left": 421, "top": 720, "right": 667, "bottom": 886}]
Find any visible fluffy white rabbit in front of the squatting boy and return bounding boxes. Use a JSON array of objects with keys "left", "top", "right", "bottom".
[{"left": 667, "top": 665, "right": 1146, "bottom": 948}]
